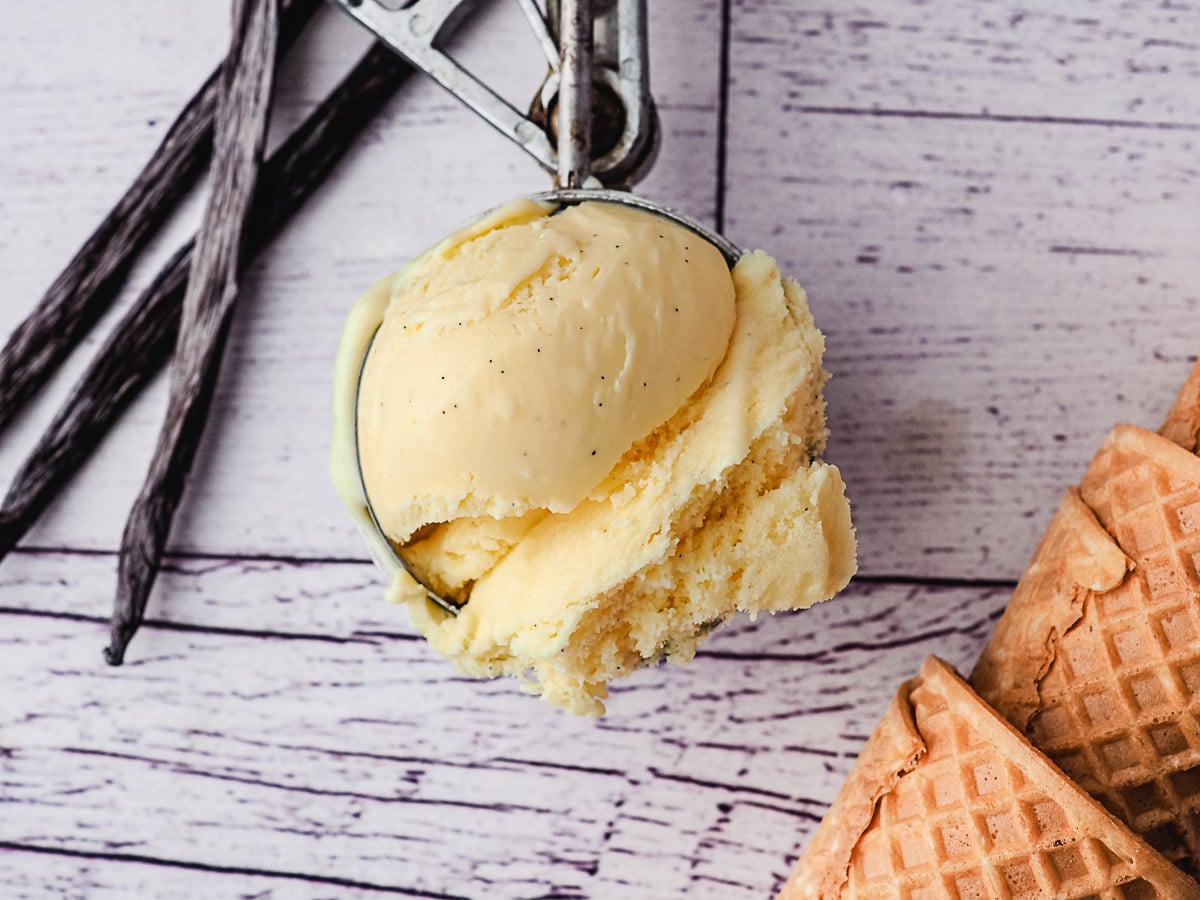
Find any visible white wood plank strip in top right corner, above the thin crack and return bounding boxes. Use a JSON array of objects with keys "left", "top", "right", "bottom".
[{"left": 732, "top": 0, "right": 1200, "bottom": 126}]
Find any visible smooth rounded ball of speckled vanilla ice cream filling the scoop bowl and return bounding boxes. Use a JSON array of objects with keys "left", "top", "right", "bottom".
[{"left": 358, "top": 200, "right": 733, "bottom": 542}]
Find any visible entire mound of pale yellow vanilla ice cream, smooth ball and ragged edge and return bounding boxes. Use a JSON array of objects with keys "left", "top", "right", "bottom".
[{"left": 332, "top": 200, "right": 856, "bottom": 715}]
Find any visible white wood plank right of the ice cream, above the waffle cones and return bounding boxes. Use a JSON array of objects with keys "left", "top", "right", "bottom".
[{"left": 727, "top": 109, "right": 1200, "bottom": 578}]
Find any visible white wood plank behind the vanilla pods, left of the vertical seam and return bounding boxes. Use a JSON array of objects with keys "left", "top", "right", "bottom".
[{"left": 0, "top": 0, "right": 720, "bottom": 558}]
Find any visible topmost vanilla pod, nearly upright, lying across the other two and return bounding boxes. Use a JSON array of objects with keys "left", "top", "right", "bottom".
[{"left": 104, "top": 0, "right": 278, "bottom": 665}]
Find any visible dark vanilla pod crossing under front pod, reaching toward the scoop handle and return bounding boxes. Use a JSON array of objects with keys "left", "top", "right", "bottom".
[{"left": 0, "top": 44, "right": 413, "bottom": 559}]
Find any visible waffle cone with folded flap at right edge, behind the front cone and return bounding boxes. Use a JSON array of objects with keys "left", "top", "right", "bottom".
[{"left": 971, "top": 388, "right": 1200, "bottom": 875}]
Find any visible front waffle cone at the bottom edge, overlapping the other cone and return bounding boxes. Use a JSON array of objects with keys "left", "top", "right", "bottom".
[{"left": 780, "top": 656, "right": 1200, "bottom": 900}]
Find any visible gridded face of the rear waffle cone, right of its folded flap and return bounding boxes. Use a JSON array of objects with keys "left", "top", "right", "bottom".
[{"left": 978, "top": 426, "right": 1200, "bottom": 872}]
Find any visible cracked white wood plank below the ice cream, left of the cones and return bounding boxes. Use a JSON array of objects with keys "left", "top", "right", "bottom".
[{"left": 0, "top": 554, "right": 1004, "bottom": 898}]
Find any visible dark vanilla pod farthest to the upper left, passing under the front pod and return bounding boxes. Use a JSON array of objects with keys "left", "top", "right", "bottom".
[{"left": 0, "top": 0, "right": 320, "bottom": 439}]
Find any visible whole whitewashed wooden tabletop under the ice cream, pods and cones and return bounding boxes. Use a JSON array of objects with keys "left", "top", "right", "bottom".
[{"left": 0, "top": 0, "right": 1200, "bottom": 900}]
